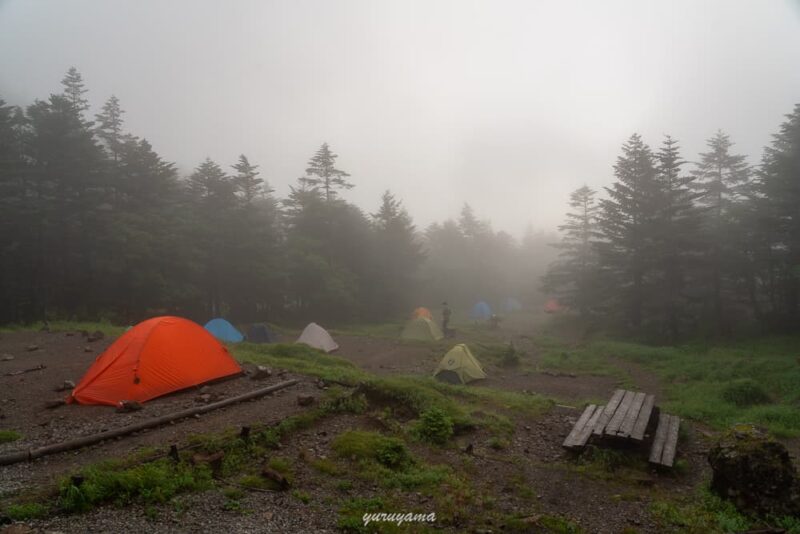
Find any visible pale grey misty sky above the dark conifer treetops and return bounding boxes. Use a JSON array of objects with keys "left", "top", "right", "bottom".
[{"left": 0, "top": 0, "right": 800, "bottom": 235}]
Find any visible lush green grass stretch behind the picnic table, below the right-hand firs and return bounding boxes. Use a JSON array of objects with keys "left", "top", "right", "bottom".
[{"left": 536, "top": 336, "right": 800, "bottom": 437}]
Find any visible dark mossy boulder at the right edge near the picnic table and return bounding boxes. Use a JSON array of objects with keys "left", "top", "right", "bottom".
[{"left": 708, "top": 425, "right": 800, "bottom": 516}]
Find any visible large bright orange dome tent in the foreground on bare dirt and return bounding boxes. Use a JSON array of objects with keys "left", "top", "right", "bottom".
[{"left": 67, "top": 317, "right": 242, "bottom": 406}]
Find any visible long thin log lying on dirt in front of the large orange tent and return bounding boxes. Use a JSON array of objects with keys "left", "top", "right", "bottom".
[{"left": 0, "top": 379, "right": 298, "bottom": 465}]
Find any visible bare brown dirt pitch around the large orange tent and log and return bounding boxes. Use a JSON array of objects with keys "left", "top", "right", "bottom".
[{"left": 0, "top": 332, "right": 321, "bottom": 496}]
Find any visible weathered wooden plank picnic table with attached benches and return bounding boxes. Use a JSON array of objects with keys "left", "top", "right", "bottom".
[{"left": 563, "top": 389, "right": 680, "bottom": 467}]
